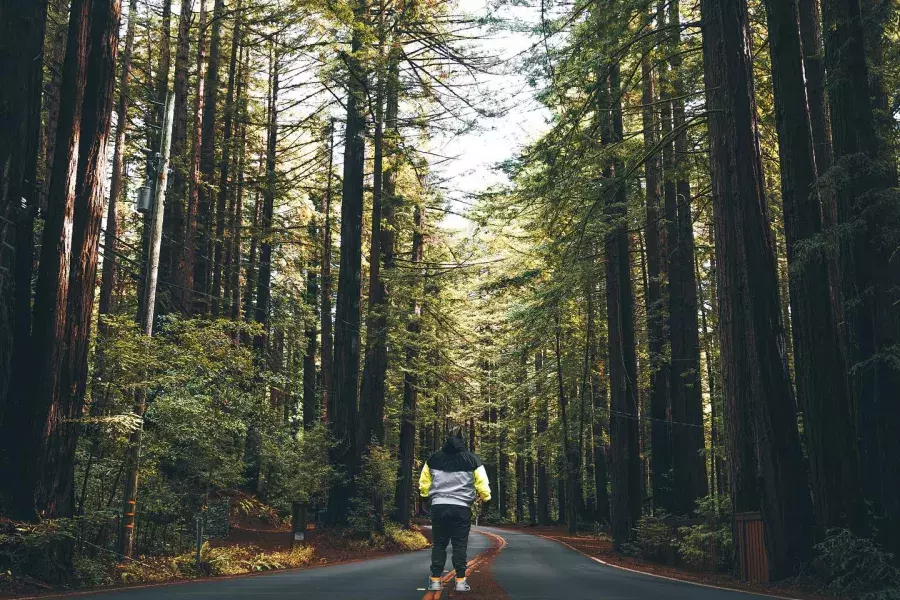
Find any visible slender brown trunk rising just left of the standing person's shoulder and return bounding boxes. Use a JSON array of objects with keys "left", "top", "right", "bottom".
[{"left": 394, "top": 206, "right": 425, "bottom": 527}]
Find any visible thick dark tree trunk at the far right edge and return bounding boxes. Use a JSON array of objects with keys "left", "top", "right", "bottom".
[{"left": 822, "top": 0, "right": 900, "bottom": 551}]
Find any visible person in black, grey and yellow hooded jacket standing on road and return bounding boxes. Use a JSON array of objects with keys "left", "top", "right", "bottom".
[{"left": 419, "top": 427, "right": 491, "bottom": 592}]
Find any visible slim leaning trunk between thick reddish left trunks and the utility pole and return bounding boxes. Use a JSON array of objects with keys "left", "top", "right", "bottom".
[{"left": 99, "top": 0, "right": 137, "bottom": 315}]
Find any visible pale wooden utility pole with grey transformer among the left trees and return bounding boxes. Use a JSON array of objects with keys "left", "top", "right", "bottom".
[{"left": 119, "top": 92, "right": 175, "bottom": 558}]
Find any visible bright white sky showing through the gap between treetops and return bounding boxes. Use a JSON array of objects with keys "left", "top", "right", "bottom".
[{"left": 432, "top": 0, "right": 549, "bottom": 231}]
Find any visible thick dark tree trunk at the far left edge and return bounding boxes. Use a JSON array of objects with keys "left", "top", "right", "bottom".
[{"left": 0, "top": 0, "right": 47, "bottom": 492}]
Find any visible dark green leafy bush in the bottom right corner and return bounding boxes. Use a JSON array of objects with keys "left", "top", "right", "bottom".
[{"left": 816, "top": 529, "right": 900, "bottom": 600}]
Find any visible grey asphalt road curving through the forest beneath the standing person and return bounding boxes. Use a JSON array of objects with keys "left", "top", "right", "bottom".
[{"left": 63, "top": 528, "right": 780, "bottom": 600}]
